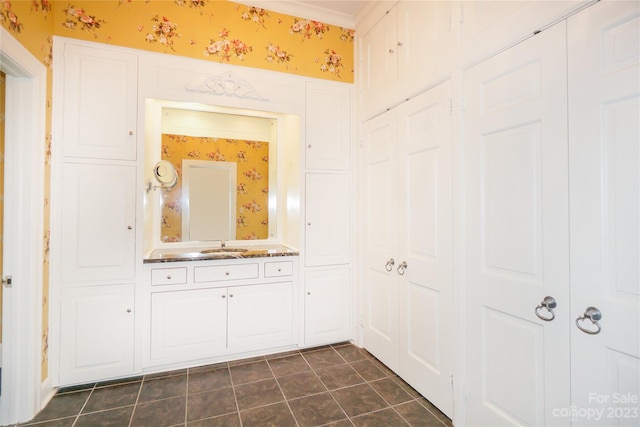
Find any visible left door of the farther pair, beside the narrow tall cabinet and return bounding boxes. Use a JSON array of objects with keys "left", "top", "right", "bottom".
[{"left": 362, "top": 113, "right": 400, "bottom": 371}]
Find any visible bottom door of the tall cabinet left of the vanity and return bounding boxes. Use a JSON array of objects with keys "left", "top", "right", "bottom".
[{"left": 60, "top": 284, "right": 134, "bottom": 385}]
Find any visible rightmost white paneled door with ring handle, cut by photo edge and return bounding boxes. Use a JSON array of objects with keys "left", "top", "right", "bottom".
[{"left": 562, "top": 2, "right": 640, "bottom": 426}]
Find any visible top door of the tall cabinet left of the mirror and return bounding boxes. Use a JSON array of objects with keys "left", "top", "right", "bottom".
[{"left": 62, "top": 44, "right": 138, "bottom": 160}]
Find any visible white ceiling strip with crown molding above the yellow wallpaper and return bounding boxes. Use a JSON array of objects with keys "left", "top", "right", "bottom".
[{"left": 234, "top": 0, "right": 377, "bottom": 28}]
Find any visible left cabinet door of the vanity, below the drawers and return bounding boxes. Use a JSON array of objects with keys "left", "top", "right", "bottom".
[{"left": 149, "top": 288, "right": 227, "bottom": 363}]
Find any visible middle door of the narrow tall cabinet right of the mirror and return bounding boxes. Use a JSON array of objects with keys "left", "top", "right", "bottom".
[{"left": 305, "top": 173, "right": 351, "bottom": 266}]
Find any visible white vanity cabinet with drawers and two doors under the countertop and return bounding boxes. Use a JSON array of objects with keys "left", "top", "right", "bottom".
[{"left": 143, "top": 256, "right": 298, "bottom": 368}]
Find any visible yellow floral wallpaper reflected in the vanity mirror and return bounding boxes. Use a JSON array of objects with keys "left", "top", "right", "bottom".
[{"left": 160, "top": 134, "right": 269, "bottom": 242}]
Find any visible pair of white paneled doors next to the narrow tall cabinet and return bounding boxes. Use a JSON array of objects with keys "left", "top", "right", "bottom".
[{"left": 363, "top": 81, "right": 453, "bottom": 416}]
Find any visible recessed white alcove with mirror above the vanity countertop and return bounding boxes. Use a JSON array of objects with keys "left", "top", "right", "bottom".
[{"left": 144, "top": 99, "right": 300, "bottom": 253}]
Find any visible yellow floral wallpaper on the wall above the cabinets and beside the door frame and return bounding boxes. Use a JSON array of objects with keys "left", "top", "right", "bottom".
[{"left": 0, "top": 0, "right": 354, "bottom": 381}]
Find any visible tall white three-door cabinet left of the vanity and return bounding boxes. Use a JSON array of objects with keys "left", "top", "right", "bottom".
[{"left": 51, "top": 44, "right": 138, "bottom": 384}]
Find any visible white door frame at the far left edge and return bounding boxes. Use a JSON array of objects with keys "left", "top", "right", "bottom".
[{"left": 0, "top": 28, "right": 52, "bottom": 425}]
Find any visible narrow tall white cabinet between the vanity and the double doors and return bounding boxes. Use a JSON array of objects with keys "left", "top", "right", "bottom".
[{"left": 302, "top": 82, "right": 353, "bottom": 346}]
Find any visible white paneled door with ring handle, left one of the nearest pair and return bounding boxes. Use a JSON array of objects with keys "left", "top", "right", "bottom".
[{"left": 463, "top": 23, "right": 571, "bottom": 426}]
